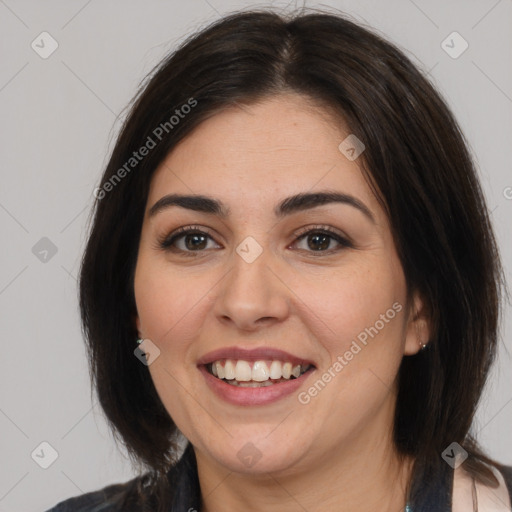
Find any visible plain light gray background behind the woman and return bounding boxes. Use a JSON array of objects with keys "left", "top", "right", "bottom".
[{"left": 0, "top": 0, "right": 512, "bottom": 512}]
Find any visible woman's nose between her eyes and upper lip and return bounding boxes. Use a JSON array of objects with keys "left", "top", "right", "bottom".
[{"left": 214, "top": 244, "right": 291, "bottom": 331}]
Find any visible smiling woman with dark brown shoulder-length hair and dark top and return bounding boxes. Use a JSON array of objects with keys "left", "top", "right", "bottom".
[{"left": 46, "top": 8, "right": 512, "bottom": 512}]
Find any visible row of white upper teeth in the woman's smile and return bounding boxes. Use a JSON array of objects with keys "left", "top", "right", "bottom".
[{"left": 211, "top": 359, "right": 309, "bottom": 382}]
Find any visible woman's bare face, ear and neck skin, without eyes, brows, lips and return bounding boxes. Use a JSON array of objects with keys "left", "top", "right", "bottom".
[{"left": 135, "top": 94, "right": 429, "bottom": 512}]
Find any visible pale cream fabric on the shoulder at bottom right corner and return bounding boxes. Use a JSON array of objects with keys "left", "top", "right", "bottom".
[{"left": 452, "top": 465, "right": 512, "bottom": 512}]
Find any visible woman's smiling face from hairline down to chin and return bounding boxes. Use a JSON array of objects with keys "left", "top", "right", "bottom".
[{"left": 135, "top": 95, "right": 419, "bottom": 474}]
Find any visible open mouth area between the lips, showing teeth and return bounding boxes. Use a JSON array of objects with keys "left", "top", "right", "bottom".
[{"left": 205, "top": 359, "right": 314, "bottom": 388}]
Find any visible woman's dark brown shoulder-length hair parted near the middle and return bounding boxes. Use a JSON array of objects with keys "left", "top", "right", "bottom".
[{"left": 80, "top": 7, "right": 503, "bottom": 508}]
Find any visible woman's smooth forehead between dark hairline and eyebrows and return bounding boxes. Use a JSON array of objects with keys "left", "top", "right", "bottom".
[{"left": 148, "top": 95, "right": 379, "bottom": 216}]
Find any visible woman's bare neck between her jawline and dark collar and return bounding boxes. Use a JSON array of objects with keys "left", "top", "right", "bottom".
[{"left": 196, "top": 418, "right": 412, "bottom": 512}]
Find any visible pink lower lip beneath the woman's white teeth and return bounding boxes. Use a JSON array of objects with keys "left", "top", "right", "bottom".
[{"left": 198, "top": 365, "right": 314, "bottom": 405}]
